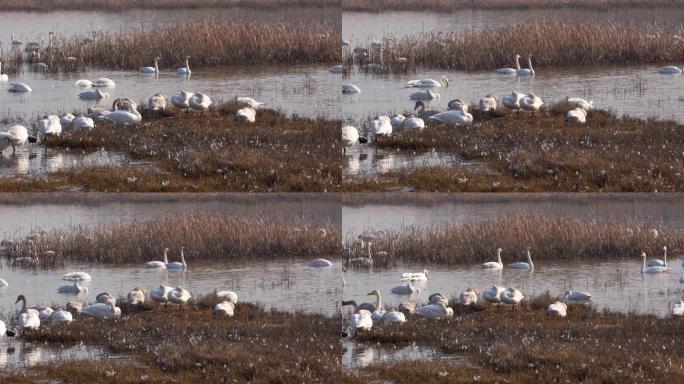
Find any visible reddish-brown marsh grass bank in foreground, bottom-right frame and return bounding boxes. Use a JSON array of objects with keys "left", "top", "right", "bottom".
[{"left": 348, "top": 294, "right": 684, "bottom": 383}]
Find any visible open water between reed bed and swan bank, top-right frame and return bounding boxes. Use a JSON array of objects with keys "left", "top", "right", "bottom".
[{"left": 342, "top": 62, "right": 684, "bottom": 127}]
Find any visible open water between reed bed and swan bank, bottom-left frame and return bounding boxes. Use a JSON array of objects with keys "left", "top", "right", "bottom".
[{"left": 0, "top": 258, "right": 342, "bottom": 320}]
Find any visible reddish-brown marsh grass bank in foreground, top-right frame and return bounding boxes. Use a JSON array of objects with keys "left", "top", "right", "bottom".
[{"left": 345, "top": 103, "right": 684, "bottom": 192}]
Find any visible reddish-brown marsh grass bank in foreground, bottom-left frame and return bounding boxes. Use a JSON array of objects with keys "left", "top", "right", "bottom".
[{"left": 13, "top": 297, "right": 342, "bottom": 383}]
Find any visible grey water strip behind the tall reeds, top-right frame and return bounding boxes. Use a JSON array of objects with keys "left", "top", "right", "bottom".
[{"left": 342, "top": 9, "right": 684, "bottom": 41}]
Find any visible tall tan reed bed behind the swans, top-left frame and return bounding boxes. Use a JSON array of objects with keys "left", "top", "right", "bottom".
[{"left": 3, "top": 21, "right": 341, "bottom": 73}]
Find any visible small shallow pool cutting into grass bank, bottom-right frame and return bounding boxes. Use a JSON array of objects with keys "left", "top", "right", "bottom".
[{"left": 342, "top": 340, "right": 465, "bottom": 370}]
